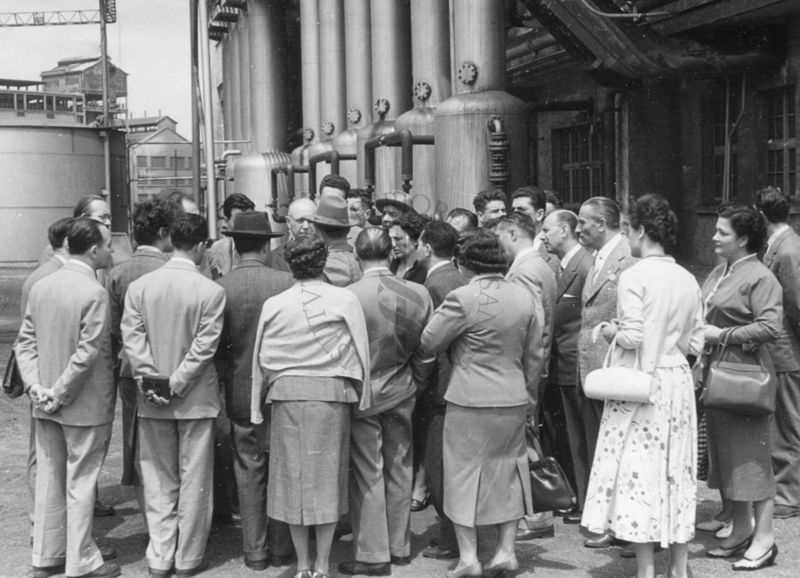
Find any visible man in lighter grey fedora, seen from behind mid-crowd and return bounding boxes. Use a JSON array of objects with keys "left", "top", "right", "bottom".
[{"left": 306, "top": 195, "right": 361, "bottom": 287}]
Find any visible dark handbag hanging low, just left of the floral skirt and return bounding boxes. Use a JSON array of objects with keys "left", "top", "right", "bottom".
[{"left": 525, "top": 425, "right": 578, "bottom": 513}]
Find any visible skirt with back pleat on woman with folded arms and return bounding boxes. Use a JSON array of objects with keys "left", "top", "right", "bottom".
[{"left": 442, "top": 403, "right": 533, "bottom": 527}]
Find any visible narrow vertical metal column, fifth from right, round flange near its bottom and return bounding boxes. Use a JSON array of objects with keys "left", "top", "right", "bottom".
[{"left": 315, "top": 0, "right": 346, "bottom": 140}]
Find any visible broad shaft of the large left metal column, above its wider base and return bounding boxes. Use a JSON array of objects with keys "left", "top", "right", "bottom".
[{"left": 247, "top": 0, "right": 288, "bottom": 152}]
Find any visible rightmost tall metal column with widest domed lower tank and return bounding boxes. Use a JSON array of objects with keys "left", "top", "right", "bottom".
[{"left": 434, "top": 0, "right": 528, "bottom": 211}]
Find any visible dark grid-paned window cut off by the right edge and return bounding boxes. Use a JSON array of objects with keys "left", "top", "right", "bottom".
[{"left": 764, "top": 86, "right": 797, "bottom": 198}]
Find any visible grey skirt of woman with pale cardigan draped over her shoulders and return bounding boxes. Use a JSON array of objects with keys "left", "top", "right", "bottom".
[{"left": 267, "top": 401, "right": 350, "bottom": 526}]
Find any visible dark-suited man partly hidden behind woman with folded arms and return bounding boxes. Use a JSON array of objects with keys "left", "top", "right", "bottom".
[{"left": 414, "top": 220, "right": 466, "bottom": 560}]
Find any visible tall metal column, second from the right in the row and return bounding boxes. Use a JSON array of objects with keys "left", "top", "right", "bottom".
[{"left": 394, "top": 0, "right": 450, "bottom": 214}]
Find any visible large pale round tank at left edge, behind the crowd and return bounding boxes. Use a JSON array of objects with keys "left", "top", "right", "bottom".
[{"left": 0, "top": 125, "right": 130, "bottom": 264}]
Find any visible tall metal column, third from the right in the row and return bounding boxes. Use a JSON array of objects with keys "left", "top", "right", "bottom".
[{"left": 358, "top": 0, "right": 411, "bottom": 194}]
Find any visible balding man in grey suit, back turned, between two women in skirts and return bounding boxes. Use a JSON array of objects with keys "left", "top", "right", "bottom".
[{"left": 339, "top": 227, "right": 433, "bottom": 576}]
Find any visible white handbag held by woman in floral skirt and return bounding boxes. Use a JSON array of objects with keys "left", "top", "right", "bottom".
[{"left": 583, "top": 335, "right": 655, "bottom": 403}]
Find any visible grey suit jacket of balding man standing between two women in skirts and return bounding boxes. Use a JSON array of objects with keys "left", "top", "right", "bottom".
[{"left": 348, "top": 268, "right": 433, "bottom": 417}]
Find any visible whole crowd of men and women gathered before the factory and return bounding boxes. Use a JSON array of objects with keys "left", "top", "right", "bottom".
[{"left": 15, "top": 175, "right": 800, "bottom": 578}]
